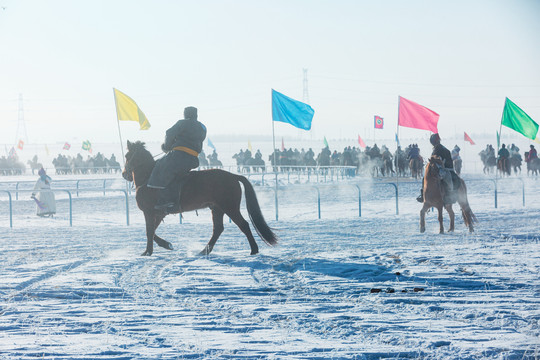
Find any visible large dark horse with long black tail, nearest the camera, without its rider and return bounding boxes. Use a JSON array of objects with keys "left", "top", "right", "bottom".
[{"left": 122, "top": 141, "right": 277, "bottom": 256}]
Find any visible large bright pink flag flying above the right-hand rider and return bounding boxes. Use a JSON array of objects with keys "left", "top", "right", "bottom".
[{"left": 398, "top": 96, "right": 439, "bottom": 133}]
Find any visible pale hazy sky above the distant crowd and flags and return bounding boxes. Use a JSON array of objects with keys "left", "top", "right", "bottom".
[{"left": 0, "top": 0, "right": 540, "bottom": 148}]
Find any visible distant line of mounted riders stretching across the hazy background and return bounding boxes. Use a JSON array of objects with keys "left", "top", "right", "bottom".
[{"left": 4, "top": 144, "right": 540, "bottom": 178}]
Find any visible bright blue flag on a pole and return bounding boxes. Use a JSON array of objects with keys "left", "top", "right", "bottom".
[{"left": 272, "top": 89, "right": 315, "bottom": 130}]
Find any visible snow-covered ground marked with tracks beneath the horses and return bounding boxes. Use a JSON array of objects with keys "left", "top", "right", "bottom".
[{"left": 0, "top": 173, "right": 540, "bottom": 359}]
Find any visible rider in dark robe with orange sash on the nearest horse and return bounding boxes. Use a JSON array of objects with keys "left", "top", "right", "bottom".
[{"left": 148, "top": 106, "right": 206, "bottom": 213}]
